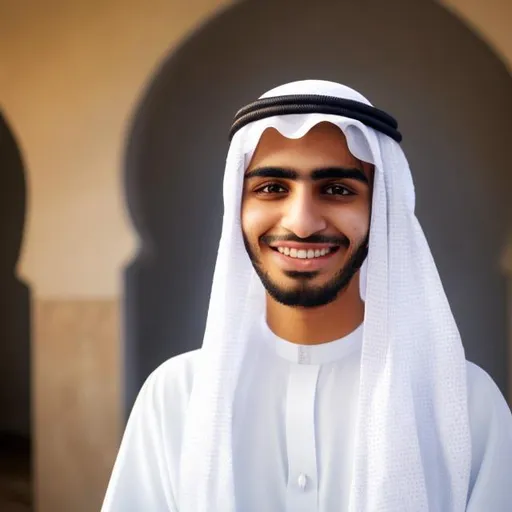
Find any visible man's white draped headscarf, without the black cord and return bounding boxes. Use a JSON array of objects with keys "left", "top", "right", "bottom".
[{"left": 178, "top": 80, "right": 471, "bottom": 512}]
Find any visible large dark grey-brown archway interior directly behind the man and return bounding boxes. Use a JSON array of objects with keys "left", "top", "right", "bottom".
[{"left": 125, "top": 0, "right": 512, "bottom": 410}]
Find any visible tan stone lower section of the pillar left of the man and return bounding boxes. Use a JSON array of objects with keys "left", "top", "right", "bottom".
[{"left": 33, "top": 299, "right": 122, "bottom": 512}]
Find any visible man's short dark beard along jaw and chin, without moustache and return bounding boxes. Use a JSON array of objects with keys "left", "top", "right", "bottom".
[{"left": 244, "top": 235, "right": 369, "bottom": 308}]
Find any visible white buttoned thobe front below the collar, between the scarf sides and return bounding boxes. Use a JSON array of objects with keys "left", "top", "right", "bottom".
[{"left": 233, "top": 359, "right": 359, "bottom": 512}]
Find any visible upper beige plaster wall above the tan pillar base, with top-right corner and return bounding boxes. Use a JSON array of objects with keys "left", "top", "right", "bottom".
[{"left": 0, "top": 0, "right": 512, "bottom": 298}]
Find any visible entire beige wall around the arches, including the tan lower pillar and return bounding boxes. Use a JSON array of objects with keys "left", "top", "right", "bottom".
[{"left": 0, "top": 0, "right": 512, "bottom": 512}]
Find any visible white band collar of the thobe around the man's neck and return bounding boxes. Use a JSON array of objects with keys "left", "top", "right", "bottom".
[{"left": 262, "top": 320, "right": 363, "bottom": 365}]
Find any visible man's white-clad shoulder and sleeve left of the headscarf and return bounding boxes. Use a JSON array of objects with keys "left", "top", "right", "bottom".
[{"left": 102, "top": 350, "right": 201, "bottom": 511}]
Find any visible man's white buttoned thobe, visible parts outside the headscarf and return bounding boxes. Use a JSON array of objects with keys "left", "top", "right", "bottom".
[{"left": 102, "top": 322, "right": 512, "bottom": 512}]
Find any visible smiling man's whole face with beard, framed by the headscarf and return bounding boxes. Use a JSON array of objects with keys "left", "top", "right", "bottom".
[{"left": 241, "top": 123, "right": 373, "bottom": 307}]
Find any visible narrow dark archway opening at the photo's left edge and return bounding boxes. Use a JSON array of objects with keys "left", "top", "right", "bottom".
[{"left": 0, "top": 112, "right": 31, "bottom": 510}]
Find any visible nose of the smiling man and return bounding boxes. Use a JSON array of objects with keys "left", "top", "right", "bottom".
[{"left": 281, "top": 190, "right": 327, "bottom": 238}]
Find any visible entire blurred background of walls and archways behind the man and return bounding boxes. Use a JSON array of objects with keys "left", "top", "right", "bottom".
[{"left": 0, "top": 0, "right": 512, "bottom": 512}]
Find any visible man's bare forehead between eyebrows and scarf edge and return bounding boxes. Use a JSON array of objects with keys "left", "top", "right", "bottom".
[{"left": 247, "top": 122, "right": 361, "bottom": 171}]
